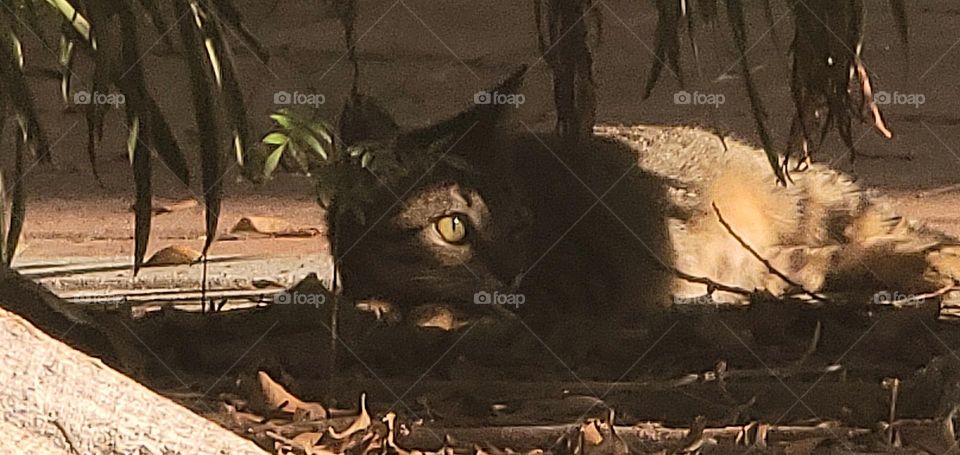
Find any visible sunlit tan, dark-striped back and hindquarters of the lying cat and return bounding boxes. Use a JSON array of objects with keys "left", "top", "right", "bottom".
[{"left": 595, "top": 125, "right": 945, "bottom": 302}]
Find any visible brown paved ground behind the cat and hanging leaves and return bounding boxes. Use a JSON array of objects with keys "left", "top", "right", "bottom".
[{"left": 4, "top": 0, "right": 960, "bottom": 278}]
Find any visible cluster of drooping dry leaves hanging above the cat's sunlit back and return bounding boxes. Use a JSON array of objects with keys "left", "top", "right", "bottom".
[{"left": 636, "top": 0, "right": 909, "bottom": 184}]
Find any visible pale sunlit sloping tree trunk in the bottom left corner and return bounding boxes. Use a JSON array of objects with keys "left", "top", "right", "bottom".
[{"left": 0, "top": 272, "right": 265, "bottom": 454}]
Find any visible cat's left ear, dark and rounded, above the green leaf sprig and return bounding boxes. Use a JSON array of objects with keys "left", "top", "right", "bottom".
[{"left": 340, "top": 93, "right": 400, "bottom": 145}]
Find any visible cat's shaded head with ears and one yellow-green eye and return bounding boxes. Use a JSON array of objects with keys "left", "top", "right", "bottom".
[{"left": 328, "top": 68, "right": 533, "bottom": 314}]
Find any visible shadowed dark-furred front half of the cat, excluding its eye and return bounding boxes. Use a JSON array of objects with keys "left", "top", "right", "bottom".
[{"left": 329, "top": 71, "right": 672, "bottom": 356}]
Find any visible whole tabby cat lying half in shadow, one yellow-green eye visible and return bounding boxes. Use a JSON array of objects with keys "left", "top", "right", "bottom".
[{"left": 327, "top": 69, "right": 957, "bottom": 360}]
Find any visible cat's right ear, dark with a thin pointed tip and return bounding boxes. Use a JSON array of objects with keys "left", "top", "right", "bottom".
[{"left": 399, "top": 65, "right": 527, "bottom": 161}]
